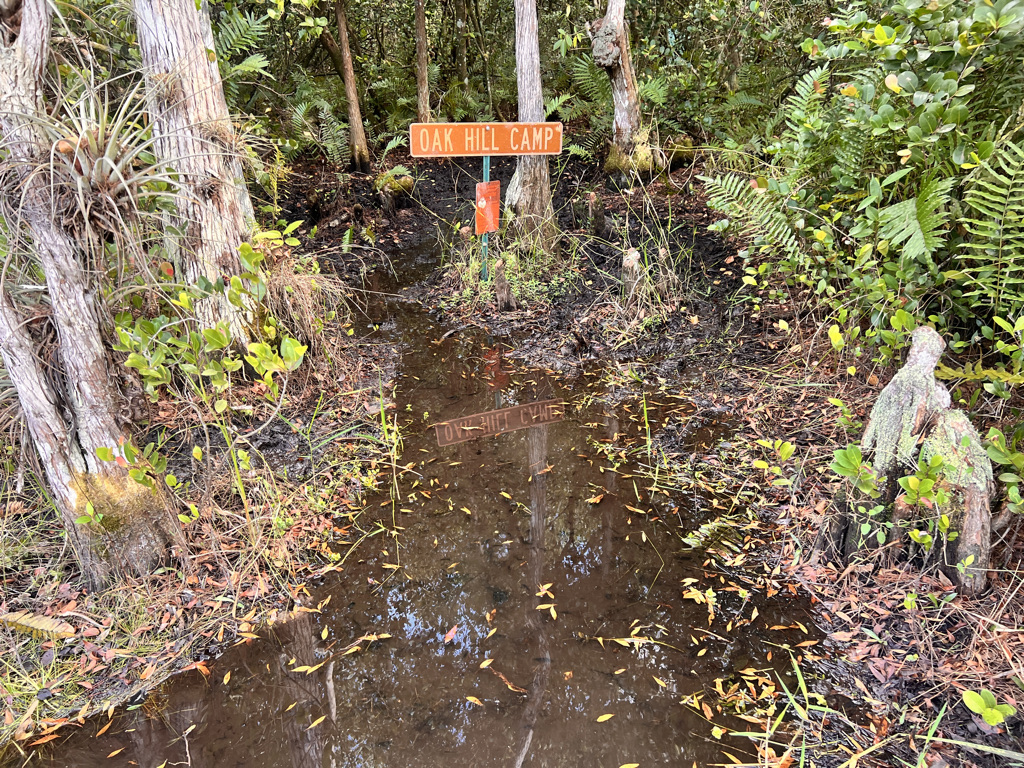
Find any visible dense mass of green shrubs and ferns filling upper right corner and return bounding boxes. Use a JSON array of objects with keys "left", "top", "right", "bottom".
[{"left": 707, "top": 0, "right": 1024, "bottom": 379}]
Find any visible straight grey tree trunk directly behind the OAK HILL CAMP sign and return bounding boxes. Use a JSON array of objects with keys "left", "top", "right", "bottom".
[{"left": 513, "top": 0, "right": 555, "bottom": 250}]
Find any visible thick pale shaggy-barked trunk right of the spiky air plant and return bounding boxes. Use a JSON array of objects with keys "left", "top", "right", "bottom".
[{"left": 133, "top": 0, "right": 255, "bottom": 344}]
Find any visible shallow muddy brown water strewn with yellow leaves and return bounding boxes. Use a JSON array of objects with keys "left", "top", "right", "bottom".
[{"left": 36, "top": 243, "right": 809, "bottom": 768}]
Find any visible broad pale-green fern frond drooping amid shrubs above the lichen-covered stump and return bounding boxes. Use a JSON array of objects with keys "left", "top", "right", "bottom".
[{"left": 879, "top": 177, "right": 953, "bottom": 274}]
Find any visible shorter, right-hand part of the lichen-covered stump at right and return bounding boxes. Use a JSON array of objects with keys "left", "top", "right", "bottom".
[{"left": 921, "top": 411, "right": 995, "bottom": 595}]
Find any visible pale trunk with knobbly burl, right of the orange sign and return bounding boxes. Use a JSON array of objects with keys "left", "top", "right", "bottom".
[{"left": 591, "top": 0, "right": 640, "bottom": 157}]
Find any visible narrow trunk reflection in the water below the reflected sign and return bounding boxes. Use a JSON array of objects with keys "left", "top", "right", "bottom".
[{"left": 515, "top": 424, "right": 551, "bottom": 768}]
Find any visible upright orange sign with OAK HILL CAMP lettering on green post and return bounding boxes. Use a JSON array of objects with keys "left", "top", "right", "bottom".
[{"left": 409, "top": 123, "right": 562, "bottom": 158}]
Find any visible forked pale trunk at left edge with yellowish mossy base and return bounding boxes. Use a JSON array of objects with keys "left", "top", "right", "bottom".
[{"left": 0, "top": 0, "right": 182, "bottom": 586}]
